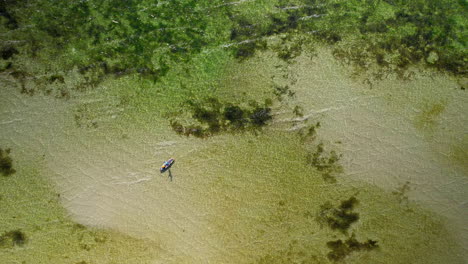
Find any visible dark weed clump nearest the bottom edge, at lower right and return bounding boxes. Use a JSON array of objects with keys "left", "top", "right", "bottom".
[{"left": 327, "top": 234, "right": 379, "bottom": 261}]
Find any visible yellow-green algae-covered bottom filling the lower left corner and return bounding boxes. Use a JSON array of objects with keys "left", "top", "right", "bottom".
[{"left": 0, "top": 159, "right": 160, "bottom": 264}]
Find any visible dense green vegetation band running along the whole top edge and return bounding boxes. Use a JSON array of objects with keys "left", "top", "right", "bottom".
[{"left": 0, "top": 0, "right": 468, "bottom": 97}]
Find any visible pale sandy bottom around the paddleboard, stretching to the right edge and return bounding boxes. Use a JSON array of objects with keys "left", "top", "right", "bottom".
[{"left": 0, "top": 48, "right": 468, "bottom": 263}]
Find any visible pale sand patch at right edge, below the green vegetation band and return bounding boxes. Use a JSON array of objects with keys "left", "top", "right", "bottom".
[{"left": 290, "top": 52, "right": 468, "bottom": 252}]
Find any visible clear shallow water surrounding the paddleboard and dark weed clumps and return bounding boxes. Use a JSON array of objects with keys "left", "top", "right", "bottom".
[{"left": 0, "top": 1, "right": 468, "bottom": 264}]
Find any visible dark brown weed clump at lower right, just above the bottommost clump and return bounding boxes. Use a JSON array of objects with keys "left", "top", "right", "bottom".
[{"left": 316, "top": 196, "right": 359, "bottom": 233}]
